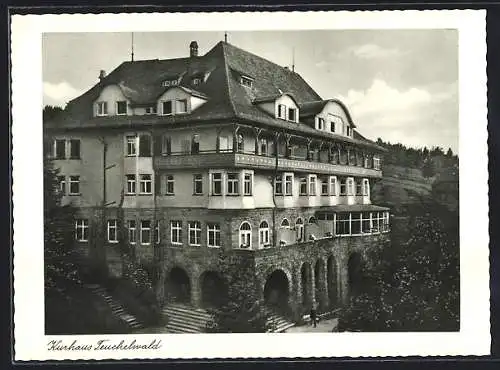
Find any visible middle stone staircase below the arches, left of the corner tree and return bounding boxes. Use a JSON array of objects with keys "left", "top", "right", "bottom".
[{"left": 162, "top": 303, "right": 212, "bottom": 333}]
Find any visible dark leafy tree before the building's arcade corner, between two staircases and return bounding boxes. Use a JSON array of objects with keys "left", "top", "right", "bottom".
[{"left": 206, "top": 252, "right": 273, "bottom": 333}]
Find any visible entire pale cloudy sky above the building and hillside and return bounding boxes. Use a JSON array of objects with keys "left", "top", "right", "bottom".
[{"left": 42, "top": 29, "right": 458, "bottom": 153}]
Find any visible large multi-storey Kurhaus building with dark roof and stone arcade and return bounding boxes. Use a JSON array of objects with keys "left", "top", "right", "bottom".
[{"left": 45, "top": 42, "right": 389, "bottom": 318}]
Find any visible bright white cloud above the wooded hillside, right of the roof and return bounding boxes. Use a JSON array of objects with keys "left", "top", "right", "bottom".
[{"left": 340, "top": 79, "right": 458, "bottom": 152}]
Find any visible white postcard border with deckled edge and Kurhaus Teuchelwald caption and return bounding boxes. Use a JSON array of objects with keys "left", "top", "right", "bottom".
[{"left": 11, "top": 10, "right": 490, "bottom": 361}]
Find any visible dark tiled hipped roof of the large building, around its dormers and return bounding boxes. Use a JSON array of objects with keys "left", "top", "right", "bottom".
[{"left": 48, "top": 42, "right": 380, "bottom": 150}]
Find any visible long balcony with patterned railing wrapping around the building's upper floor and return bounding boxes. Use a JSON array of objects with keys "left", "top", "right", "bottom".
[{"left": 154, "top": 152, "right": 382, "bottom": 178}]
